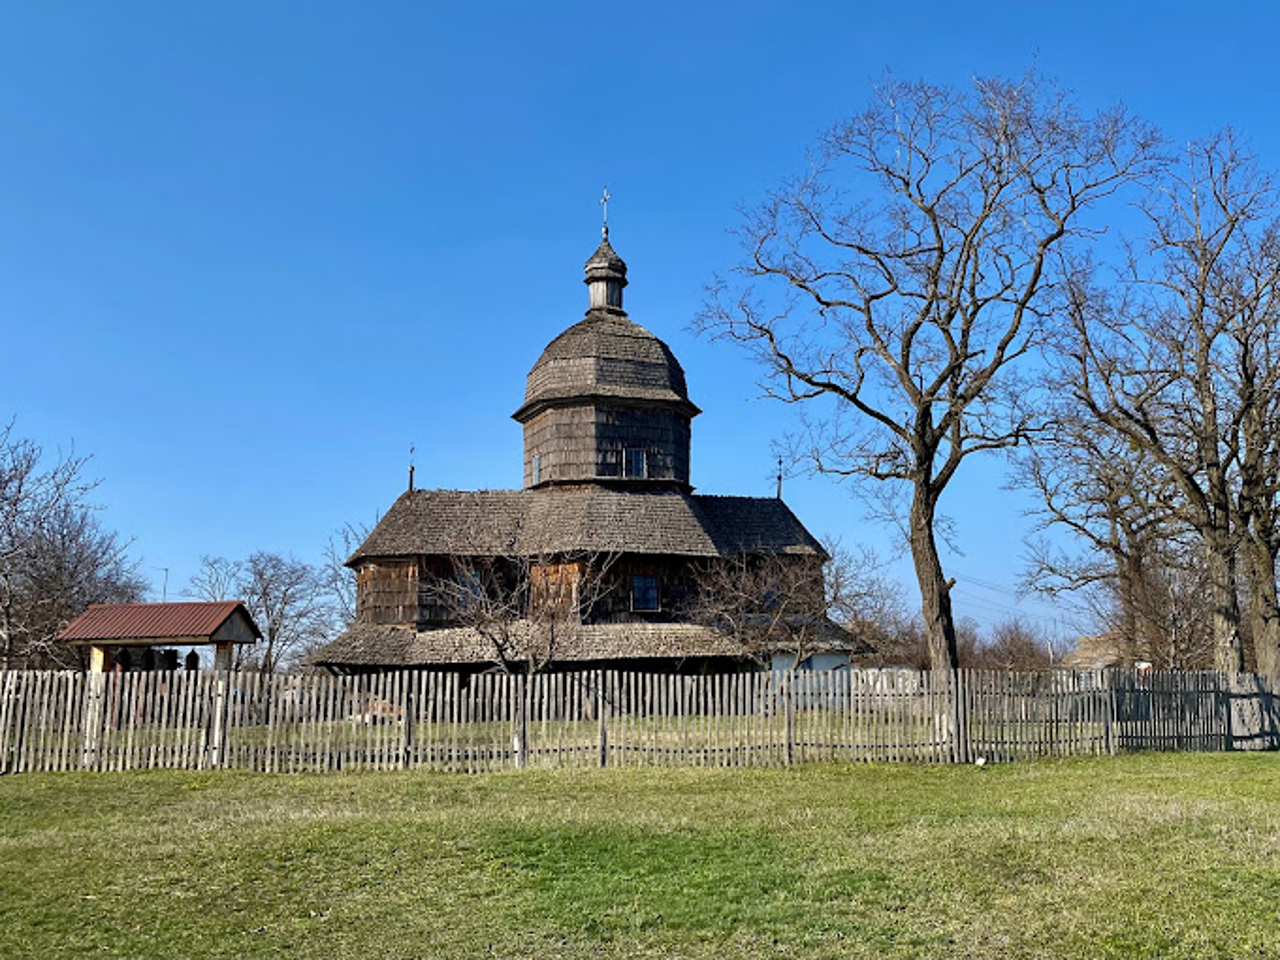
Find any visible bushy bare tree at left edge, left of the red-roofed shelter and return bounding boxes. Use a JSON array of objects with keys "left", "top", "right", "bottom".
[{"left": 0, "top": 421, "right": 146, "bottom": 668}]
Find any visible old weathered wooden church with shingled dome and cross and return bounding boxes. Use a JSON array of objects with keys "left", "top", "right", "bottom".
[{"left": 310, "top": 227, "right": 854, "bottom": 673}]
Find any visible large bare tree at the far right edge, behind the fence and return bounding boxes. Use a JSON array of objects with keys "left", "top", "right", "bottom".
[{"left": 1066, "top": 132, "right": 1280, "bottom": 672}]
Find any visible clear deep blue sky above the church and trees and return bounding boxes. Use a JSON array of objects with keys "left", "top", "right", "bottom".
[{"left": 0, "top": 0, "right": 1280, "bottom": 640}]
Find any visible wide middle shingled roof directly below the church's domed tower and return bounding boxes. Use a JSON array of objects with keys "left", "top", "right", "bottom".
[{"left": 347, "top": 485, "right": 826, "bottom": 566}]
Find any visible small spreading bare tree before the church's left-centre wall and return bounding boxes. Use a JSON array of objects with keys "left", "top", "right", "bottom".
[{"left": 422, "top": 552, "right": 618, "bottom": 675}]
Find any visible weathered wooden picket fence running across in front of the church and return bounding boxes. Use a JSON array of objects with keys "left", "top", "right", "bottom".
[{"left": 0, "top": 669, "right": 1280, "bottom": 773}]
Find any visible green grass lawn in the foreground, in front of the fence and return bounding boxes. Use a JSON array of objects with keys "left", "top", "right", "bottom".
[{"left": 0, "top": 754, "right": 1280, "bottom": 957}]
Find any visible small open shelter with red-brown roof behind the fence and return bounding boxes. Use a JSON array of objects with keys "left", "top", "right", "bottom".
[{"left": 58, "top": 600, "right": 262, "bottom": 673}]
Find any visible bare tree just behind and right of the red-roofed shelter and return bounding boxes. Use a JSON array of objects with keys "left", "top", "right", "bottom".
[{"left": 184, "top": 550, "right": 337, "bottom": 673}]
